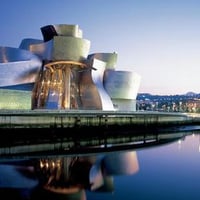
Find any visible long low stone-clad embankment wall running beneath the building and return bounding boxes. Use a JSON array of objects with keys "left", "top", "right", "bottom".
[{"left": 0, "top": 110, "right": 195, "bottom": 128}]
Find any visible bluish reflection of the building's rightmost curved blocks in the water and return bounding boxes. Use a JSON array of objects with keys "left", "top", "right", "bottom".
[{"left": 89, "top": 151, "right": 139, "bottom": 192}]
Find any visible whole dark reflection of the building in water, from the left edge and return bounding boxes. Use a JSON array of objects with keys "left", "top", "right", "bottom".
[{"left": 0, "top": 152, "right": 139, "bottom": 200}]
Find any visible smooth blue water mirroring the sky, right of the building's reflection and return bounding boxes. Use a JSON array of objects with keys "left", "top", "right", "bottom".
[{"left": 87, "top": 135, "right": 200, "bottom": 200}]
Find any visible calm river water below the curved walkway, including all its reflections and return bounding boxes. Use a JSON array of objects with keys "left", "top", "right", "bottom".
[{"left": 0, "top": 127, "right": 200, "bottom": 200}]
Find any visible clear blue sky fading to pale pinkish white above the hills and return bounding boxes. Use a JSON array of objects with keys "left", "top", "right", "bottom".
[{"left": 0, "top": 0, "right": 200, "bottom": 95}]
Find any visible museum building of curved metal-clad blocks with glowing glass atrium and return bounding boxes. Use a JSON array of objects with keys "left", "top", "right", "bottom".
[{"left": 0, "top": 24, "right": 140, "bottom": 111}]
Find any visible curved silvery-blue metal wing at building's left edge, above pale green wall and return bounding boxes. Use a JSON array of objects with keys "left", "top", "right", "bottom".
[{"left": 0, "top": 47, "right": 42, "bottom": 87}]
